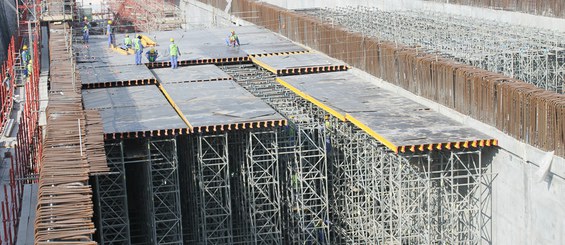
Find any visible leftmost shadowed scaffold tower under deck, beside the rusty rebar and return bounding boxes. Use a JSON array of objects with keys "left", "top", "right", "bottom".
[{"left": 94, "top": 142, "right": 130, "bottom": 244}]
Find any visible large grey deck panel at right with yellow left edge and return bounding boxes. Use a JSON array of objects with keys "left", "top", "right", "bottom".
[{"left": 282, "top": 72, "right": 491, "bottom": 146}]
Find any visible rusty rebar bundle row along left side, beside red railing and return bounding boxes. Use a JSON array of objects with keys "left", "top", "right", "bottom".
[{"left": 35, "top": 24, "right": 109, "bottom": 244}]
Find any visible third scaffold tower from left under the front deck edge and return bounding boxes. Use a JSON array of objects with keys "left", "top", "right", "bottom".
[{"left": 197, "top": 133, "right": 233, "bottom": 244}]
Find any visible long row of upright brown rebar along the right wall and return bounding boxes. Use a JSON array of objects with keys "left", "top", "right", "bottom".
[{"left": 201, "top": 0, "right": 565, "bottom": 156}]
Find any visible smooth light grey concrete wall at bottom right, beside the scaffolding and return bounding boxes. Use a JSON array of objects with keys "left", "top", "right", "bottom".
[{"left": 491, "top": 150, "right": 565, "bottom": 245}]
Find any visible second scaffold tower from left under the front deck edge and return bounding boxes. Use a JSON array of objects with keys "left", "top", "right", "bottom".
[{"left": 147, "top": 139, "right": 183, "bottom": 244}]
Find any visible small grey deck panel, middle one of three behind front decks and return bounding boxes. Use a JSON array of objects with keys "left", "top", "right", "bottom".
[{"left": 152, "top": 65, "right": 231, "bottom": 84}]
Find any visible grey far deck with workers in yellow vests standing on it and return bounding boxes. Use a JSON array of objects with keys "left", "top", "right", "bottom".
[{"left": 75, "top": 26, "right": 306, "bottom": 67}]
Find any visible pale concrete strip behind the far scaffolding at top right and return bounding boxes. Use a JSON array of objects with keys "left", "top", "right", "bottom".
[{"left": 263, "top": 0, "right": 565, "bottom": 31}]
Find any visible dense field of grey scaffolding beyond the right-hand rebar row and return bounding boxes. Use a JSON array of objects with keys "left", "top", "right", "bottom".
[{"left": 304, "top": 6, "right": 565, "bottom": 93}]
